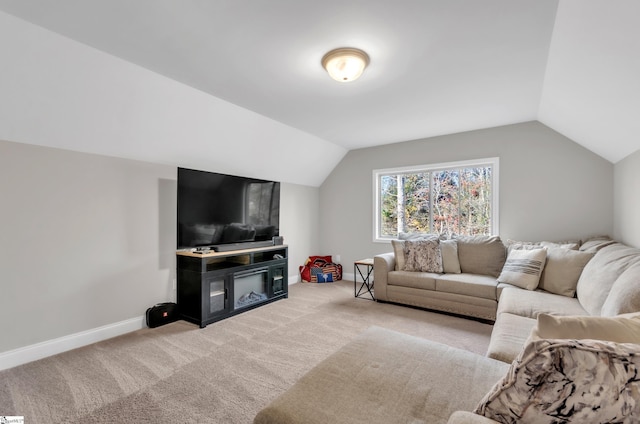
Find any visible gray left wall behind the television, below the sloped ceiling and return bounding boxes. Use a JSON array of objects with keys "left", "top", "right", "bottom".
[{"left": 0, "top": 141, "right": 319, "bottom": 353}]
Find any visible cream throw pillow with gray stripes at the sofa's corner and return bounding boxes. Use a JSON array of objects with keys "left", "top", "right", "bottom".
[{"left": 498, "top": 249, "right": 547, "bottom": 290}]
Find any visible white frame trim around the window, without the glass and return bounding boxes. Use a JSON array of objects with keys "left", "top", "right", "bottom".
[{"left": 373, "top": 157, "right": 500, "bottom": 243}]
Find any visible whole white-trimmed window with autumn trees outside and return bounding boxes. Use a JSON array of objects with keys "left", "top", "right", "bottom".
[{"left": 373, "top": 158, "right": 499, "bottom": 241}]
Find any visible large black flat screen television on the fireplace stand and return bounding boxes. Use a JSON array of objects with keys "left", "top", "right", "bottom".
[{"left": 177, "top": 168, "right": 280, "bottom": 251}]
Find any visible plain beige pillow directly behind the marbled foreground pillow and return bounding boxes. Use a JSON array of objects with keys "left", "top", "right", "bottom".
[{"left": 531, "top": 312, "right": 640, "bottom": 344}]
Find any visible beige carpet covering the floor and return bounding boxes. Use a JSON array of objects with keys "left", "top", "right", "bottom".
[{"left": 0, "top": 281, "right": 491, "bottom": 424}]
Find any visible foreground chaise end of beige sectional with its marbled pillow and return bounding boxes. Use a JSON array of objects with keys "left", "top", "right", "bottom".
[{"left": 254, "top": 320, "right": 640, "bottom": 424}]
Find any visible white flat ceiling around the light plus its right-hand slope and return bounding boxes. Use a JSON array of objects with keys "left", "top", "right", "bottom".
[{"left": 0, "top": 0, "right": 640, "bottom": 185}]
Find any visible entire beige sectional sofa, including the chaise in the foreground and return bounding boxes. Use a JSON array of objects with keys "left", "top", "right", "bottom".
[{"left": 254, "top": 237, "right": 640, "bottom": 424}]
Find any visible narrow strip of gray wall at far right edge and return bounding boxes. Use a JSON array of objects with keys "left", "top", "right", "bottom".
[{"left": 614, "top": 150, "right": 640, "bottom": 247}]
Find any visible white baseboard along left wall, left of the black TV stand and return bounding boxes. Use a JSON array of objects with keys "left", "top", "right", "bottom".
[{"left": 0, "top": 317, "right": 147, "bottom": 371}]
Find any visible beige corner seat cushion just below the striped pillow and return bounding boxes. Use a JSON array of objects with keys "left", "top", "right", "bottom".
[{"left": 498, "top": 287, "right": 588, "bottom": 318}]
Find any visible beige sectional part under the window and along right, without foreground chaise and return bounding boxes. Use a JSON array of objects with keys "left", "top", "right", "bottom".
[{"left": 374, "top": 236, "right": 640, "bottom": 362}]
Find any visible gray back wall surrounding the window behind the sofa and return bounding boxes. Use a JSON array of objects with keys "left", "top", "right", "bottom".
[{"left": 320, "top": 121, "right": 613, "bottom": 272}]
